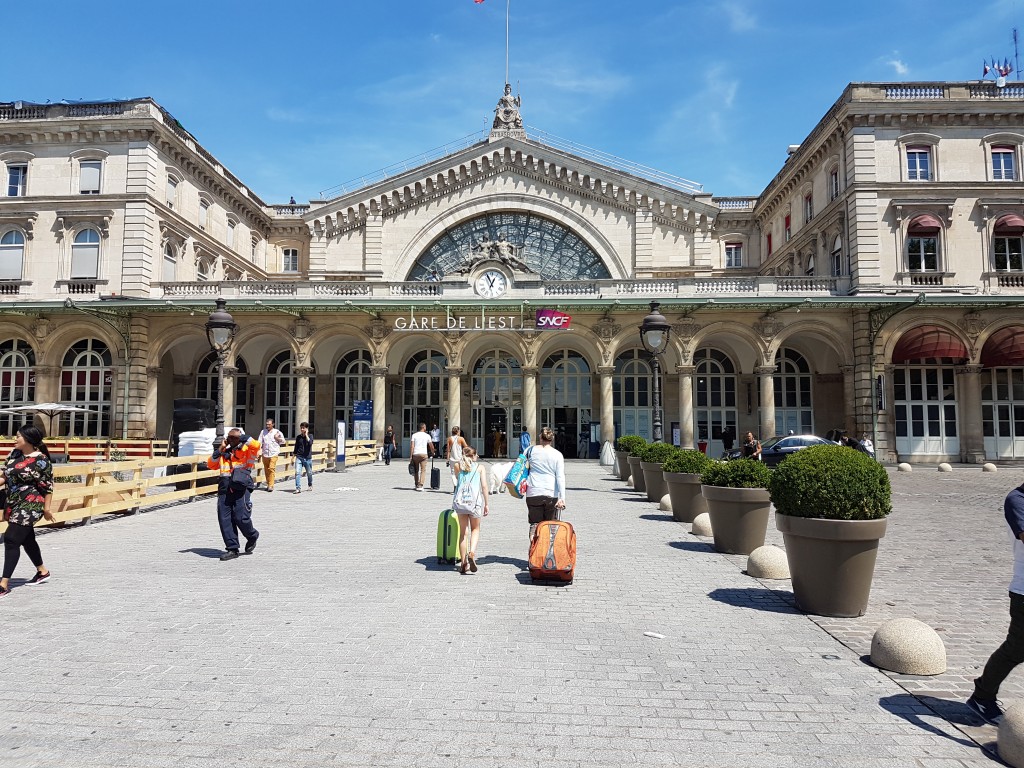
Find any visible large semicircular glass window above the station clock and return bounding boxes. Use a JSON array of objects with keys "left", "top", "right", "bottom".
[{"left": 409, "top": 212, "right": 611, "bottom": 280}]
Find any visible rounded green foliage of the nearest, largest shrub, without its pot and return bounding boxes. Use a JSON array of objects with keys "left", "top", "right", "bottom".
[{"left": 768, "top": 445, "right": 892, "bottom": 520}]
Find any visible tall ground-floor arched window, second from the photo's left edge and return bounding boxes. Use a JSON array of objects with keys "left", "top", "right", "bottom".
[{"left": 59, "top": 339, "right": 114, "bottom": 437}]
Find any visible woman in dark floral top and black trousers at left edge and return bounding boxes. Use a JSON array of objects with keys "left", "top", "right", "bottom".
[{"left": 0, "top": 426, "right": 53, "bottom": 597}]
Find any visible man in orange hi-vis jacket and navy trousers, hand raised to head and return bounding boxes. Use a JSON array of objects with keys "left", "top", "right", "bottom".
[{"left": 206, "top": 429, "right": 260, "bottom": 560}]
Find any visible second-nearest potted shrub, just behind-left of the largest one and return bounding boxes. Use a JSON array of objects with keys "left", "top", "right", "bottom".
[{"left": 700, "top": 459, "right": 771, "bottom": 555}]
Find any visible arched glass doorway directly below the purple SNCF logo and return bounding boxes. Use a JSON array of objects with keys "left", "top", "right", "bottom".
[{"left": 530, "top": 349, "right": 600, "bottom": 459}]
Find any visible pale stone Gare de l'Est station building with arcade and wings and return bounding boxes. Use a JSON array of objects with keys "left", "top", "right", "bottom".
[{"left": 0, "top": 82, "right": 1024, "bottom": 462}]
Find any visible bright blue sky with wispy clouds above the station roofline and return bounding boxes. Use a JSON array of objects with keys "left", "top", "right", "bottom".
[{"left": 8, "top": 0, "right": 1024, "bottom": 203}]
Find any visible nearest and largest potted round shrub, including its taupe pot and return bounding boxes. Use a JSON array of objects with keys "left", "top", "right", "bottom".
[{"left": 768, "top": 445, "right": 892, "bottom": 616}]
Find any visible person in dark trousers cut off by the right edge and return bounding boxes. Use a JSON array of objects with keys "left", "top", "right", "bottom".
[{"left": 967, "top": 485, "right": 1024, "bottom": 725}]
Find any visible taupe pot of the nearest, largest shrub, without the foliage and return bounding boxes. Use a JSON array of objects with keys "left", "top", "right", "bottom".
[{"left": 775, "top": 514, "right": 886, "bottom": 617}]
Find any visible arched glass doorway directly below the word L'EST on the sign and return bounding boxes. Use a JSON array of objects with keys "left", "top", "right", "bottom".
[{"left": 470, "top": 349, "right": 522, "bottom": 460}]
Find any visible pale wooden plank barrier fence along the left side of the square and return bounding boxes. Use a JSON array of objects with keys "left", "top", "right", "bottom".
[{"left": 0, "top": 440, "right": 377, "bottom": 534}]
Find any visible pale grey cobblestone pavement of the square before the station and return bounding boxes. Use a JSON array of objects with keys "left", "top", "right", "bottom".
[{"left": 0, "top": 462, "right": 1024, "bottom": 768}]
